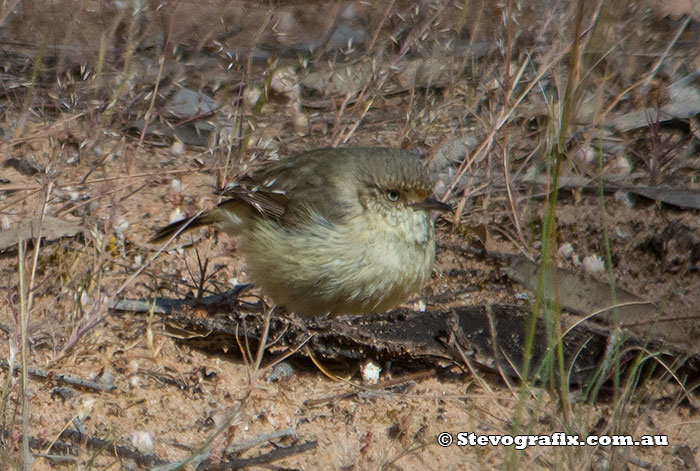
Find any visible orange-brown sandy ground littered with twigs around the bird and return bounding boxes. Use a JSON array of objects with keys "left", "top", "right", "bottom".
[{"left": 0, "top": 2, "right": 700, "bottom": 470}]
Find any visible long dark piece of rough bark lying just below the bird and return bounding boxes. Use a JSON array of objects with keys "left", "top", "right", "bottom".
[{"left": 113, "top": 296, "right": 700, "bottom": 385}]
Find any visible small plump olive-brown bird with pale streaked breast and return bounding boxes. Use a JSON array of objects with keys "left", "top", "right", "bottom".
[{"left": 152, "top": 147, "right": 450, "bottom": 316}]
